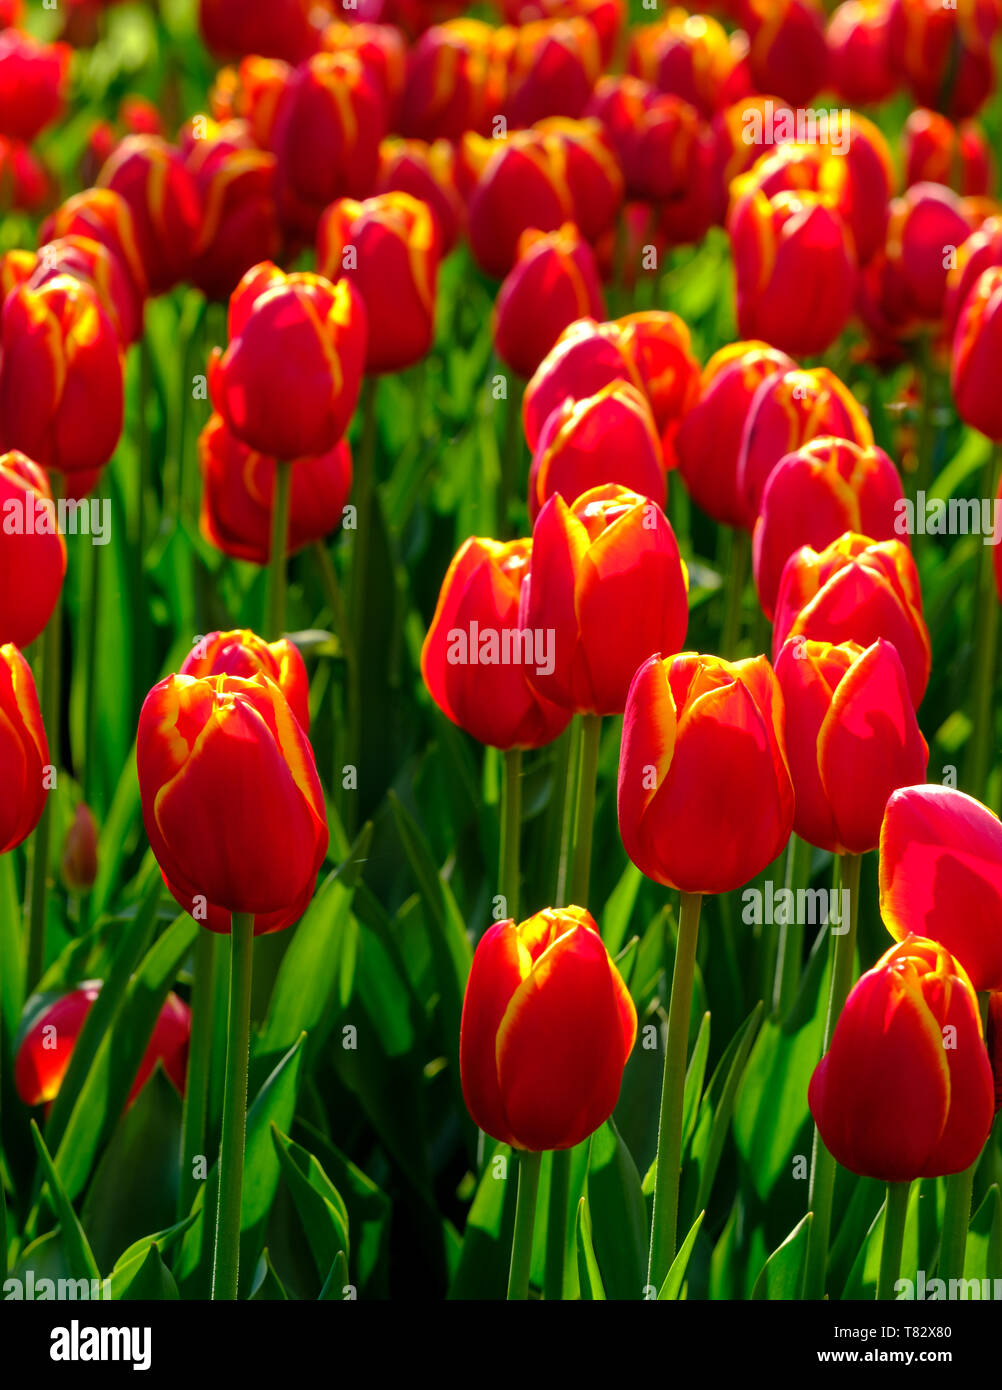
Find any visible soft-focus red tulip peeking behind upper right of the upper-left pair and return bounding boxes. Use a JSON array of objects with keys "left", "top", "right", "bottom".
[{"left": 317, "top": 193, "right": 441, "bottom": 373}]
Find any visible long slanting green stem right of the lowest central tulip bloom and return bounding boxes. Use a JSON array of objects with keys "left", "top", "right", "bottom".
[{"left": 648, "top": 892, "right": 703, "bottom": 1289}]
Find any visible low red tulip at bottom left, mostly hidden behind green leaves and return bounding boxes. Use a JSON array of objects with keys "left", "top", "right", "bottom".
[{"left": 14, "top": 980, "right": 192, "bottom": 1108}]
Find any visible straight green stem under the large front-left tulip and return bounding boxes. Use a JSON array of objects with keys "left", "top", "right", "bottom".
[{"left": 213, "top": 912, "right": 254, "bottom": 1301}]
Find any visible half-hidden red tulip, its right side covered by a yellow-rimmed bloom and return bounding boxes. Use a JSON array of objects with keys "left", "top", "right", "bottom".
[{"left": 675, "top": 339, "right": 796, "bottom": 531}]
